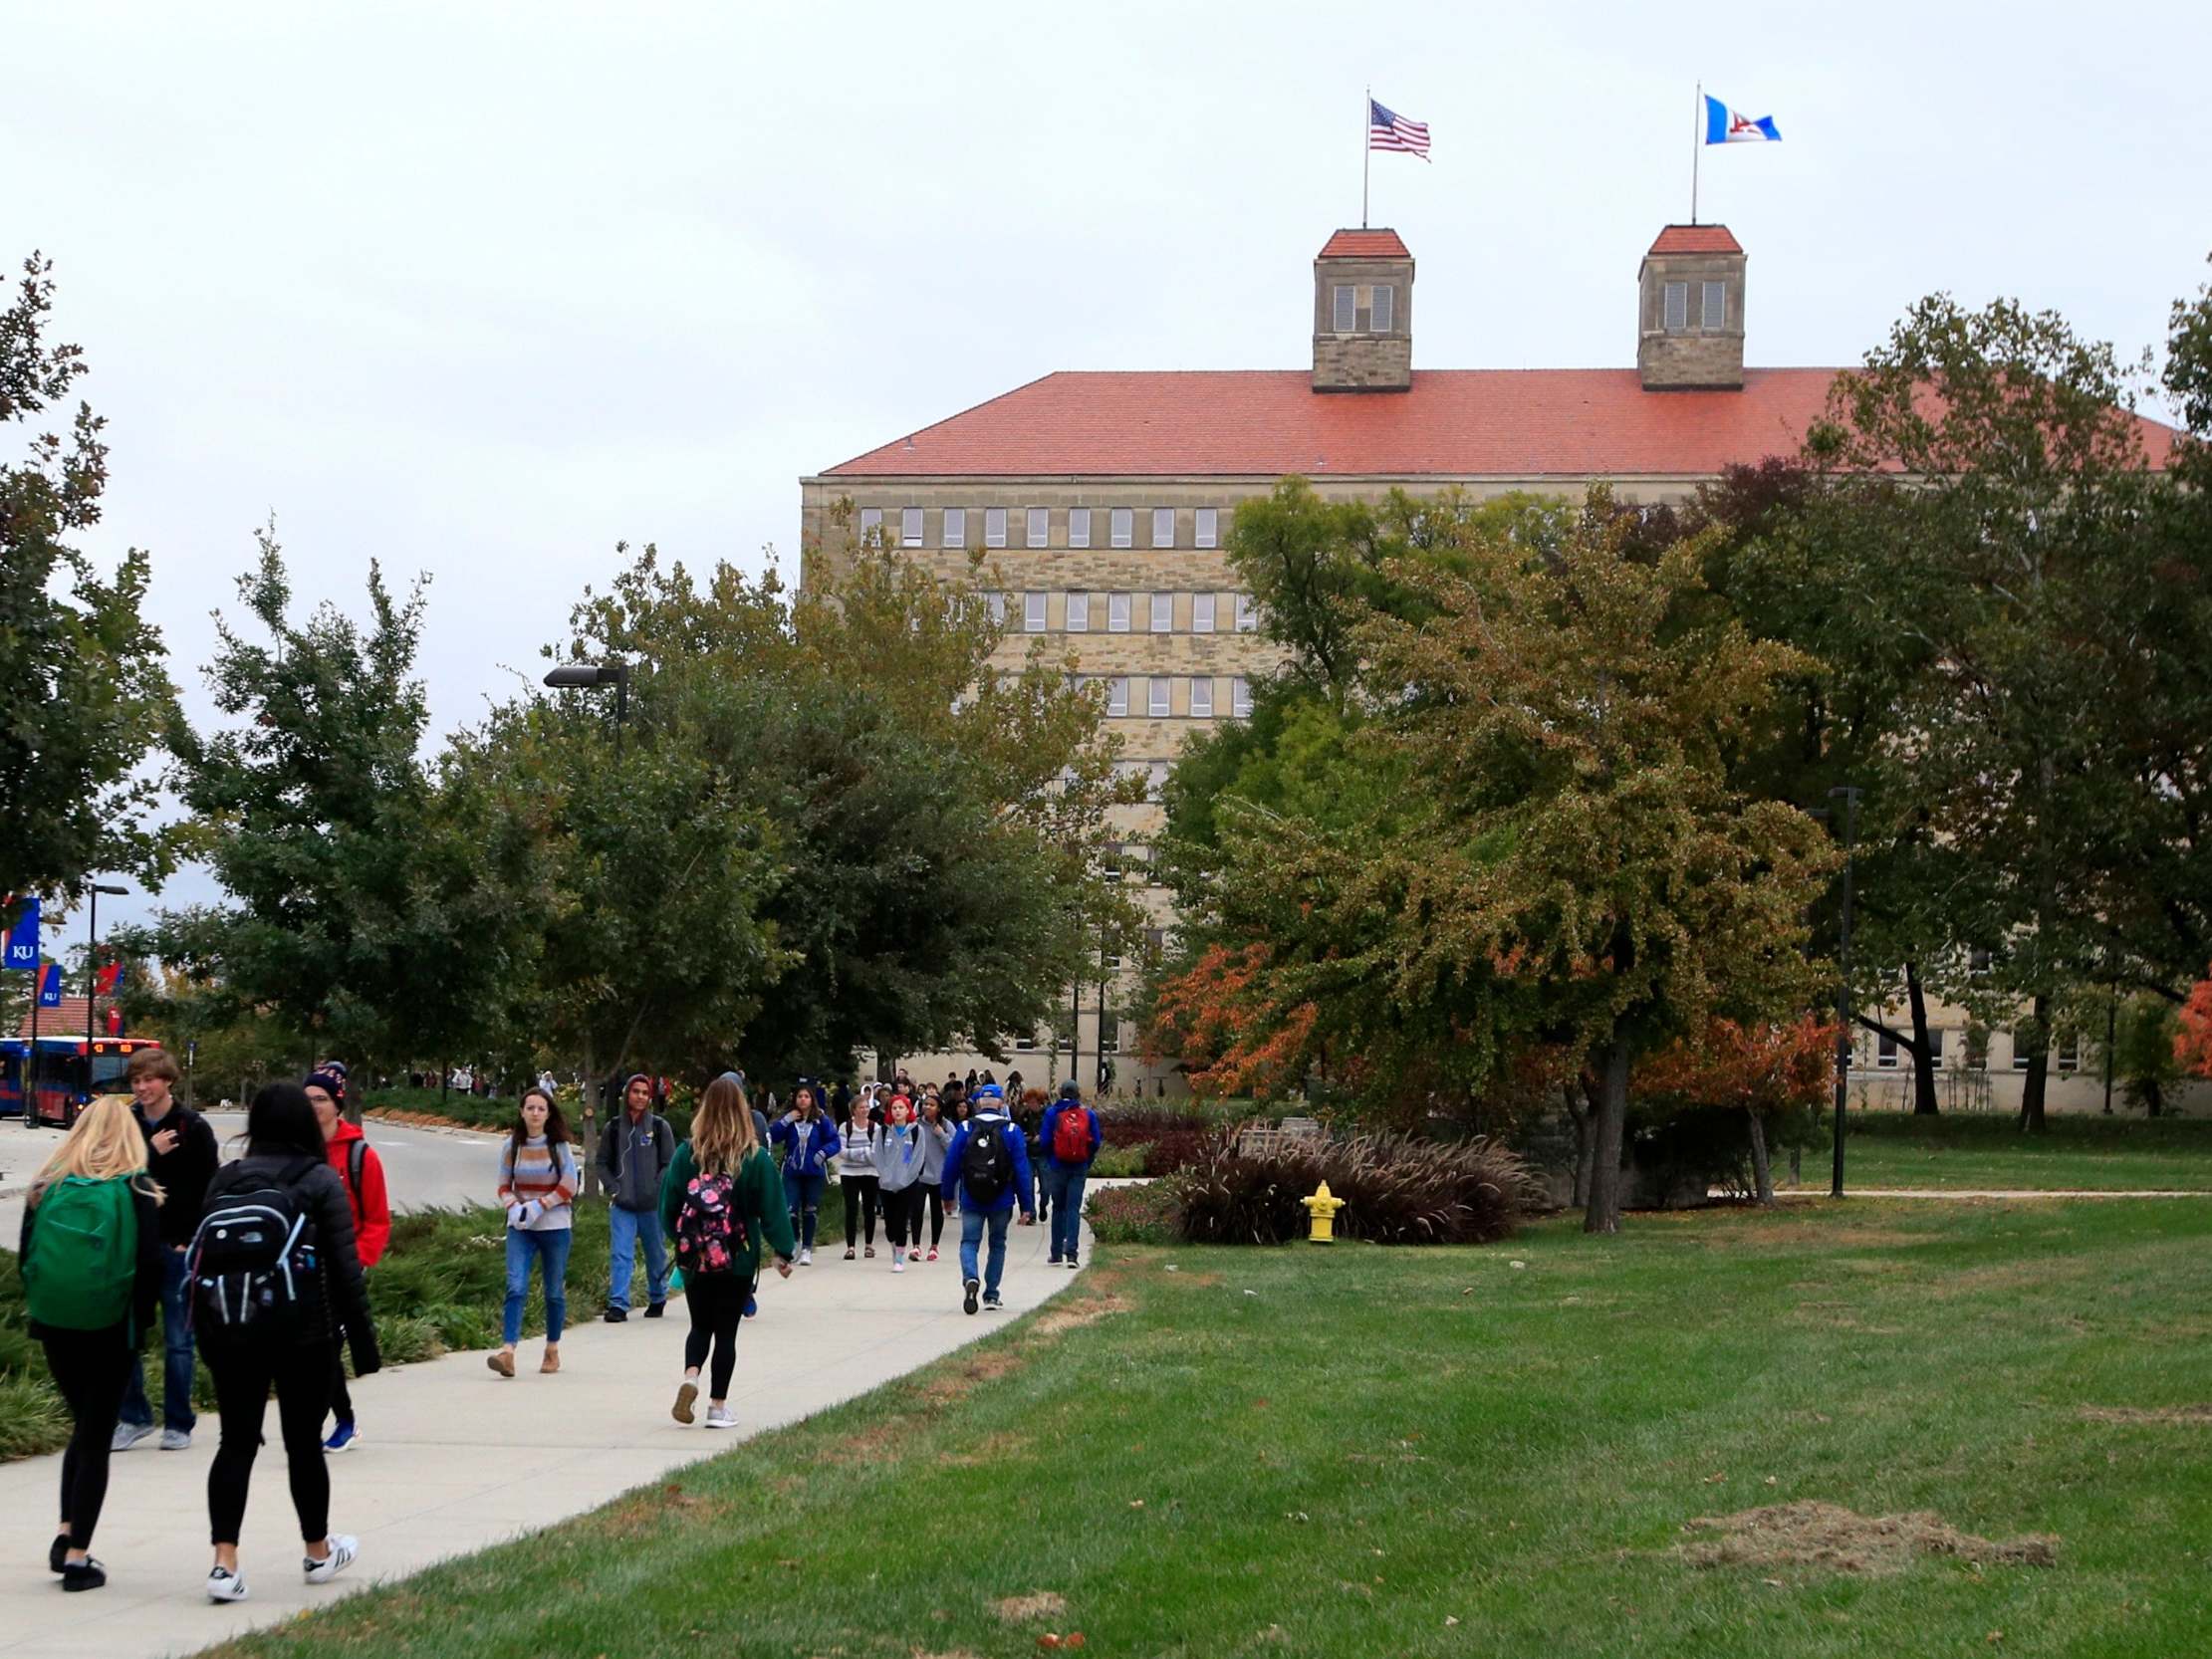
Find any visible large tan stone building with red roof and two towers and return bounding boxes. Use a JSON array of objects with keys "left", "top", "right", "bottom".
[{"left": 801, "top": 226, "right": 2170, "bottom": 1103}]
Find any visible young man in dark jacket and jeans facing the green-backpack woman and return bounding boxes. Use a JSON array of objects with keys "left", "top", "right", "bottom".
[{"left": 113, "top": 1049, "right": 219, "bottom": 1451}]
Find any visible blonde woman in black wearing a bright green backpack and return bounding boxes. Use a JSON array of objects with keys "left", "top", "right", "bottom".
[{"left": 16, "top": 1095, "right": 168, "bottom": 1590}]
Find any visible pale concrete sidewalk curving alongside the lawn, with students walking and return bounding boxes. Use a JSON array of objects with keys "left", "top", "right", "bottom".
[{"left": 0, "top": 1217, "right": 1091, "bottom": 1659}]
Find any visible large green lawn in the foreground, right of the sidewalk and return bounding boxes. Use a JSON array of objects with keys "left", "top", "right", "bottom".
[{"left": 198, "top": 1201, "right": 2212, "bottom": 1659}]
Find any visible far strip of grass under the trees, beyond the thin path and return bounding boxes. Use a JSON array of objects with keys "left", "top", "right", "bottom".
[{"left": 1781, "top": 1112, "right": 2212, "bottom": 1192}]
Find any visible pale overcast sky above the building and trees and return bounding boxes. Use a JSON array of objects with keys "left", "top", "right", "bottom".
[{"left": 0, "top": 0, "right": 2212, "bottom": 937}]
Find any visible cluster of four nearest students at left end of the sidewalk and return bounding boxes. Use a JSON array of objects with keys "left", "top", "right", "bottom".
[{"left": 20, "top": 1049, "right": 391, "bottom": 1601}]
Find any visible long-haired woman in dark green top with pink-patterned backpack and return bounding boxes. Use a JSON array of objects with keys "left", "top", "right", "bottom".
[{"left": 661, "top": 1075, "right": 792, "bottom": 1429}]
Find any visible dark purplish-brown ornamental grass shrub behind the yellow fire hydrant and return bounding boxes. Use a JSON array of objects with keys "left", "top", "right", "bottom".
[{"left": 1177, "top": 1135, "right": 1533, "bottom": 1243}]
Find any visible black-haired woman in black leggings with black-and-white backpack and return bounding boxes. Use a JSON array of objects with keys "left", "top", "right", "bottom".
[{"left": 190, "top": 1083, "right": 380, "bottom": 1601}]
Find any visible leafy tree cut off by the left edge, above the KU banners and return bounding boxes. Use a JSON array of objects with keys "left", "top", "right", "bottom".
[{"left": 0, "top": 254, "right": 174, "bottom": 927}]
